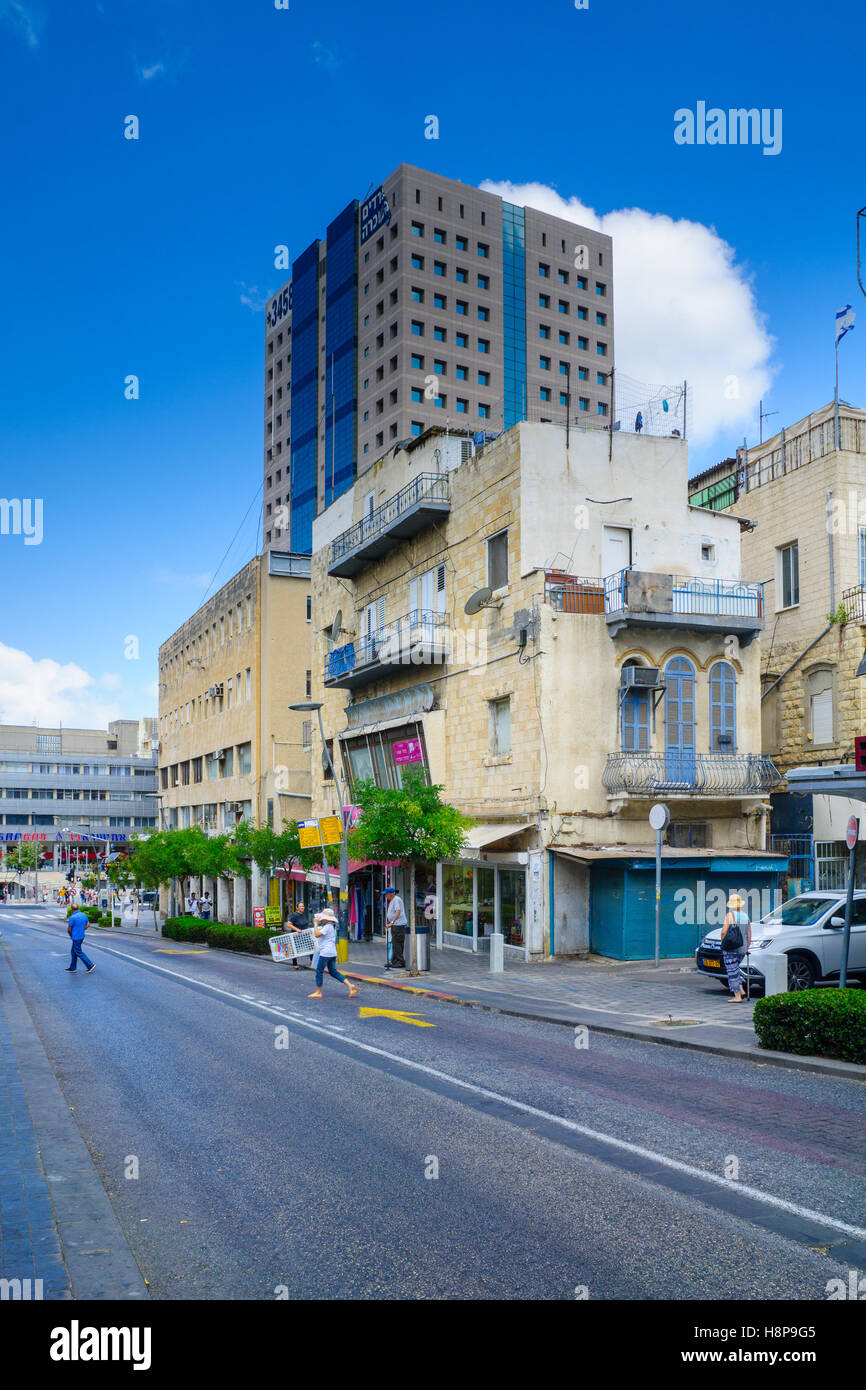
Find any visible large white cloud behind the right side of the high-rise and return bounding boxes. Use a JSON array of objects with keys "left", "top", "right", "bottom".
[{"left": 481, "top": 179, "right": 773, "bottom": 449}]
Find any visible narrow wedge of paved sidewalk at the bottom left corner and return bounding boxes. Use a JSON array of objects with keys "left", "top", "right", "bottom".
[{"left": 0, "top": 942, "right": 149, "bottom": 1301}]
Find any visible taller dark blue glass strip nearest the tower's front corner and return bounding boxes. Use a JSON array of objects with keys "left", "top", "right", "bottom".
[{"left": 322, "top": 202, "right": 359, "bottom": 506}]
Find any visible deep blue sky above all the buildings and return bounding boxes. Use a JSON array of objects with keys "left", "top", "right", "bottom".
[{"left": 0, "top": 0, "right": 866, "bottom": 723}]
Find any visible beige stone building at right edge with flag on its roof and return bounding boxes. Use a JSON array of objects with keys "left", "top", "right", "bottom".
[{"left": 689, "top": 403, "right": 866, "bottom": 887}]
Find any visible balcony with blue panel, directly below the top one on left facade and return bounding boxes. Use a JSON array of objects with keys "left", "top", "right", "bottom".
[{"left": 324, "top": 610, "right": 450, "bottom": 689}]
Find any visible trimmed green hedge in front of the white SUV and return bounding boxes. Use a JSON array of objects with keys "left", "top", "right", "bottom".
[{"left": 755, "top": 988, "right": 866, "bottom": 1062}]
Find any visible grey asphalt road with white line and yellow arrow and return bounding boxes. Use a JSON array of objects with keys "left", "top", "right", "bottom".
[{"left": 0, "top": 909, "right": 866, "bottom": 1300}]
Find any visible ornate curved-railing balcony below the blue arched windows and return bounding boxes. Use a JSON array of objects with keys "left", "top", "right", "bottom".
[{"left": 602, "top": 751, "right": 781, "bottom": 799}]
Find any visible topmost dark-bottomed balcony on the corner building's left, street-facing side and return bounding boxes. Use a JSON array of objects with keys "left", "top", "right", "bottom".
[{"left": 328, "top": 473, "right": 450, "bottom": 578}]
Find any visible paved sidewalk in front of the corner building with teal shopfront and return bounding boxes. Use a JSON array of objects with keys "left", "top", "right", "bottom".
[{"left": 342, "top": 938, "right": 866, "bottom": 1080}]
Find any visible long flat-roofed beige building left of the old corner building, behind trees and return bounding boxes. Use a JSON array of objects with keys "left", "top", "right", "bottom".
[{"left": 158, "top": 550, "right": 311, "bottom": 922}]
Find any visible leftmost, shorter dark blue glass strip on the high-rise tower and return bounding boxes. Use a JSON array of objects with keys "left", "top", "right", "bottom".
[{"left": 289, "top": 240, "right": 320, "bottom": 555}]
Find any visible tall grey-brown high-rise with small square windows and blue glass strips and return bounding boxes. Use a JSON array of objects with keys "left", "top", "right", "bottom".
[{"left": 263, "top": 164, "right": 613, "bottom": 552}]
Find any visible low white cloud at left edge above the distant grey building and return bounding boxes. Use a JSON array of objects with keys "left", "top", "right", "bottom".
[{"left": 0, "top": 642, "right": 121, "bottom": 728}]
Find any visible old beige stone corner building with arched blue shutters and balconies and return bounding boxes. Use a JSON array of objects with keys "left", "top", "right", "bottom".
[{"left": 311, "top": 423, "right": 777, "bottom": 959}]
